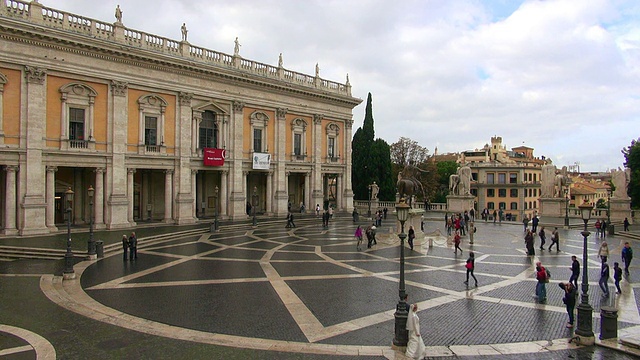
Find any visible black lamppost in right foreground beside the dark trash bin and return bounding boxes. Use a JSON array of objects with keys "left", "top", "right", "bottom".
[{"left": 576, "top": 202, "right": 595, "bottom": 345}]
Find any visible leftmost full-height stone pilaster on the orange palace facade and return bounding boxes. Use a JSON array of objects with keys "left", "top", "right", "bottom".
[{"left": 18, "top": 66, "right": 49, "bottom": 235}]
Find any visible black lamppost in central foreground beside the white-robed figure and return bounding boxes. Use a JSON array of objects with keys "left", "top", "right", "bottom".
[{"left": 393, "top": 198, "right": 410, "bottom": 346}]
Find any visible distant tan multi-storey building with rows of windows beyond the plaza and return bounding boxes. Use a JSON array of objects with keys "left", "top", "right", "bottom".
[{"left": 458, "top": 136, "right": 546, "bottom": 220}]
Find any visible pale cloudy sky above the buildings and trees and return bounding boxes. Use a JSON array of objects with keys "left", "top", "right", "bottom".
[{"left": 40, "top": 0, "right": 640, "bottom": 171}]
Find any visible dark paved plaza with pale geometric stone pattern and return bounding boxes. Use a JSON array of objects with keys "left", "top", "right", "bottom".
[{"left": 0, "top": 216, "right": 640, "bottom": 359}]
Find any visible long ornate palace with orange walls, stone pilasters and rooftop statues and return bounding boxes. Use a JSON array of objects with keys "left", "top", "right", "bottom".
[{"left": 0, "top": 0, "right": 362, "bottom": 235}]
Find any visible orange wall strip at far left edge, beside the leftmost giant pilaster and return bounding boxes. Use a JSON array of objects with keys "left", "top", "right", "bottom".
[{"left": 0, "top": 68, "right": 22, "bottom": 145}]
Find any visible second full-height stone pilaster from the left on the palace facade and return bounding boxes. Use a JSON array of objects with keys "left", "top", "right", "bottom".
[{"left": 103, "top": 80, "right": 130, "bottom": 229}]
